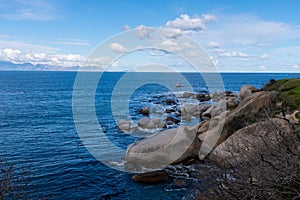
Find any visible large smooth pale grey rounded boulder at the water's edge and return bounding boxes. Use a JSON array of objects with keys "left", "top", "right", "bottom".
[{"left": 126, "top": 126, "right": 200, "bottom": 171}]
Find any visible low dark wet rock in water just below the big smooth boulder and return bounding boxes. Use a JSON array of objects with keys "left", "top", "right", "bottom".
[{"left": 132, "top": 170, "right": 169, "bottom": 184}]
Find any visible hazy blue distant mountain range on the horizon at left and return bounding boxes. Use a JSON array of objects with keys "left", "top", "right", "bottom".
[{"left": 0, "top": 61, "right": 99, "bottom": 71}]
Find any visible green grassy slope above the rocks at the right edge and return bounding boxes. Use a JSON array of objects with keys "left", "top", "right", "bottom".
[{"left": 264, "top": 78, "right": 300, "bottom": 110}]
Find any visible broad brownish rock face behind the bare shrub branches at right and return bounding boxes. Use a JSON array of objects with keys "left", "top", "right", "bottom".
[{"left": 208, "top": 118, "right": 292, "bottom": 167}]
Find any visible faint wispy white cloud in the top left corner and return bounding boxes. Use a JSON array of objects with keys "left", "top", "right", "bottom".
[{"left": 0, "top": 0, "right": 55, "bottom": 21}]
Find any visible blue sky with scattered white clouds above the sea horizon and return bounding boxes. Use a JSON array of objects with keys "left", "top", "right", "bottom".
[{"left": 0, "top": 0, "right": 300, "bottom": 72}]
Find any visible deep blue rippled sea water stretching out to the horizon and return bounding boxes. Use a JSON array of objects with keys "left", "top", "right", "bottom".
[{"left": 0, "top": 71, "right": 299, "bottom": 199}]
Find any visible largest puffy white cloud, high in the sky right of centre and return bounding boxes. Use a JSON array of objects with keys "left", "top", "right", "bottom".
[{"left": 165, "top": 14, "right": 217, "bottom": 32}]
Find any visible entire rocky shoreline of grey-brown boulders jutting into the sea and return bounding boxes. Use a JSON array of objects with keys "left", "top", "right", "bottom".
[{"left": 119, "top": 79, "right": 300, "bottom": 195}]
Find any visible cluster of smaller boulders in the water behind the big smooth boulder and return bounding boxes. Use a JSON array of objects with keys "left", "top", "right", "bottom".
[{"left": 118, "top": 91, "right": 240, "bottom": 131}]
